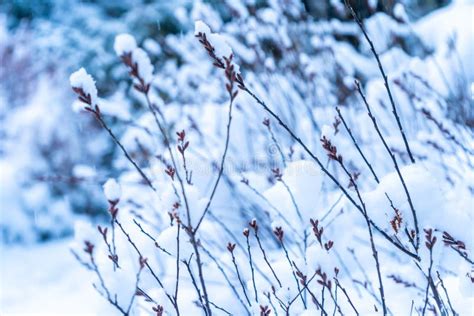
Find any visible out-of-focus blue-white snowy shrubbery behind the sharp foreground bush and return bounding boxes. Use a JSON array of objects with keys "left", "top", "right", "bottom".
[{"left": 0, "top": 0, "right": 456, "bottom": 243}]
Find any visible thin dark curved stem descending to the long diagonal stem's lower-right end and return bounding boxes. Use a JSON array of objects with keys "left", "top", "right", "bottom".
[{"left": 356, "top": 81, "right": 420, "bottom": 253}]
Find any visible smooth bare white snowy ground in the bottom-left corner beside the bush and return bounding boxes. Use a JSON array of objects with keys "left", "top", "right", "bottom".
[{"left": 0, "top": 239, "right": 103, "bottom": 316}]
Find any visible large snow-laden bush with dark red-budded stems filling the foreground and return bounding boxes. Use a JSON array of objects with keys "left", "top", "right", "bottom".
[{"left": 67, "top": 1, "right": 474, "bottom": 315}]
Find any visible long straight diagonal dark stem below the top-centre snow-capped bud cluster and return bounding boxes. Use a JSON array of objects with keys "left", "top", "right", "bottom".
[{"left": 241, "top": 87, "right": 420, "bottom": 260}]
